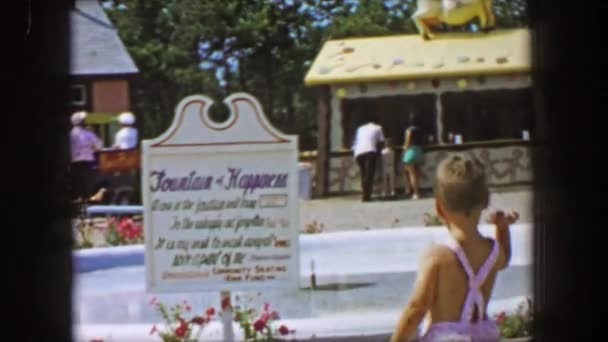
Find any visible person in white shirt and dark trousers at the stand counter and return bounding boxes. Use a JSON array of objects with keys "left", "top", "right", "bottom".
[{"left": 353, "top": 115, "right": 384, "bottom": 202}]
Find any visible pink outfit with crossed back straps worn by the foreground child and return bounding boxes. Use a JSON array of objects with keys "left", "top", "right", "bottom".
[{"left": 421, "top": 239, "right": 500, "bottom": 342}]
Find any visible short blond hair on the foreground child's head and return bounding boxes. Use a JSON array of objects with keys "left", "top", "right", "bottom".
[{"left": 434, "top": 154, "right": 489, "bottom": 216}]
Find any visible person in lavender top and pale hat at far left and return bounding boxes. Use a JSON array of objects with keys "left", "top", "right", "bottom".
[{"left": 70, "top": 112, "right": 103, "bottom": 200}]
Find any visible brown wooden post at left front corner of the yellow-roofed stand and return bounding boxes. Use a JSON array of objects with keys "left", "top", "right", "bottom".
[{"left": 315, "top": 86, "right": 331, "bottom": 198}]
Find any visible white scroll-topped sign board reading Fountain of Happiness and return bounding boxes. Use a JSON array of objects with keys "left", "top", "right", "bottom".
[{"left": 142, "top": 93, "right": 300, "bottom": 292}]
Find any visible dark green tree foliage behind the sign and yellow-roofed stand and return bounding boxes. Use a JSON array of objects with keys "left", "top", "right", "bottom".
[{"left": 104, "top": 0, "right": 527, "bottom": 149}]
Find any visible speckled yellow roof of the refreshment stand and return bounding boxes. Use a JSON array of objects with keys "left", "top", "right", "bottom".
[{"left": 304, "top": 29, "right": 531, "bottom": 85}]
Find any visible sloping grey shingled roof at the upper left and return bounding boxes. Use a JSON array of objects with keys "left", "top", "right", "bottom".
[{"left": 70, "top": 0, "right": 139, "bottom": 76}]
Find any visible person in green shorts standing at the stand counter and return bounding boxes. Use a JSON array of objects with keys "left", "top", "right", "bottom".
[{"left": 402, "top": 113, "right": 424, "bottom": 199}]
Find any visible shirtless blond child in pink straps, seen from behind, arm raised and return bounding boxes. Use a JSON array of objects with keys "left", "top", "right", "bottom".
[{"left": 391, "top": 155, "right": 519, "bottom": 342}]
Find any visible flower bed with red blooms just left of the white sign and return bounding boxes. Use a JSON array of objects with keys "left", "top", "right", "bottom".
[{"left": 72, "top": 215, "right": 144, "bottom": 249}]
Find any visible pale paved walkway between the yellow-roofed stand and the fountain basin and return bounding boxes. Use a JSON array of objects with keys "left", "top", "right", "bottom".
[{"left": 300, "top": 188, "right": 533, "bottom": 232}]
